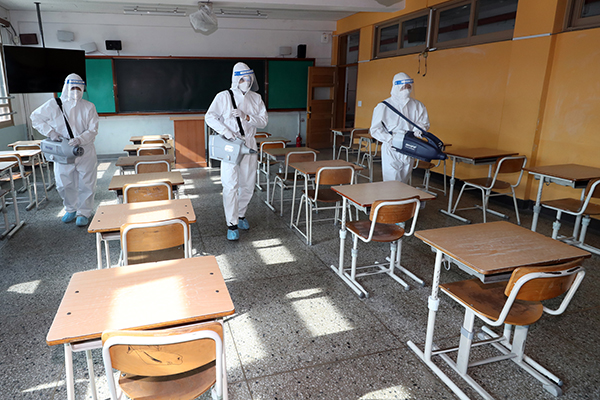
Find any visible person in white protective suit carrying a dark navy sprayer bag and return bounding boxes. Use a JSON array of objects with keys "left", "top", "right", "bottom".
[{"left": 370, "top": 72, "right": 429, "bottom": 183}]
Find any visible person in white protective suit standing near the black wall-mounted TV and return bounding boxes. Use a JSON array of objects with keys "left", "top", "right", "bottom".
[{"left": 30, "top": 74, "right": 98, "bottom": 226}]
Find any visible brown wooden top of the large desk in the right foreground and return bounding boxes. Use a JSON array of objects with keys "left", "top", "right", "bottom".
[{"left": 415, "top": 221, "right": 591, "bottom": 275}]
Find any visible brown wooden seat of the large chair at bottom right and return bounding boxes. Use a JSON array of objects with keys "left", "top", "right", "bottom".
[{"left": 440, "top": 278, "right": 544, "bottom": 326}]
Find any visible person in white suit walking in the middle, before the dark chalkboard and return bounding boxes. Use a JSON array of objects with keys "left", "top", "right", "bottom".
[{"left": 204, "top": 62, "right": 268, "bottom": 240}]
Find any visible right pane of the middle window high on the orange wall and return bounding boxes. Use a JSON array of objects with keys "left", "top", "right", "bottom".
[{"left": 475, "top": 0, "right": 518, "bottom": 35}]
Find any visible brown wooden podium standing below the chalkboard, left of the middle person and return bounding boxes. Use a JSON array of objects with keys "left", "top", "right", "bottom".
[{"left": 171, "top": 116, "right": 207, "bottom": 168}]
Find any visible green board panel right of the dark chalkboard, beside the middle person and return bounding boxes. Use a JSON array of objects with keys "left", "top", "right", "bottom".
[{"left": 267, "top": 60, "right": 314, "bottom": 110}]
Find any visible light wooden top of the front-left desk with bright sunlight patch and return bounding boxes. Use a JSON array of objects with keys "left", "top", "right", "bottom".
[{"left": 46, "top": 256, "right": 235, "bottom": 346}]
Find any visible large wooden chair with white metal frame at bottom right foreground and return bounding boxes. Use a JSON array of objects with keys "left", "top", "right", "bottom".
[{"left": 432, "top": 259, "right": 585, "bottom": 399}]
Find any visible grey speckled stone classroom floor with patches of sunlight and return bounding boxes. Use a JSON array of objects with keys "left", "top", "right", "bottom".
[{"left": 0, "top": 151, "right": 600, "bottom": 400}]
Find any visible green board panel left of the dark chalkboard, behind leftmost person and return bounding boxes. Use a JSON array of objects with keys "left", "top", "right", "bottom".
[{"left": 85, "top": 58, "right": 116, "bottom": 113}]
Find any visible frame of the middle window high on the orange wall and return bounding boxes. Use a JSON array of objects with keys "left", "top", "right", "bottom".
[{"left": 431, "top": 0, "right": 514, "bottom": 49}]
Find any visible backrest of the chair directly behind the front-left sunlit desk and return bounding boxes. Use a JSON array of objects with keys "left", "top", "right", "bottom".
[{"left": 121, "top": 217, "right": 191, "bottom": 265}]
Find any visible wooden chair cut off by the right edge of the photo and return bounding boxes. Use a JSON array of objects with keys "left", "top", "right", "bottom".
[{"left": 542, "top": 179, "right": 600, "bottom": 254}]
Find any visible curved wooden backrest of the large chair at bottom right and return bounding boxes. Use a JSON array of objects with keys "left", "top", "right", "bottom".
[{"left": 504, "top": 258, "right": 585, "bottom": 301}]
